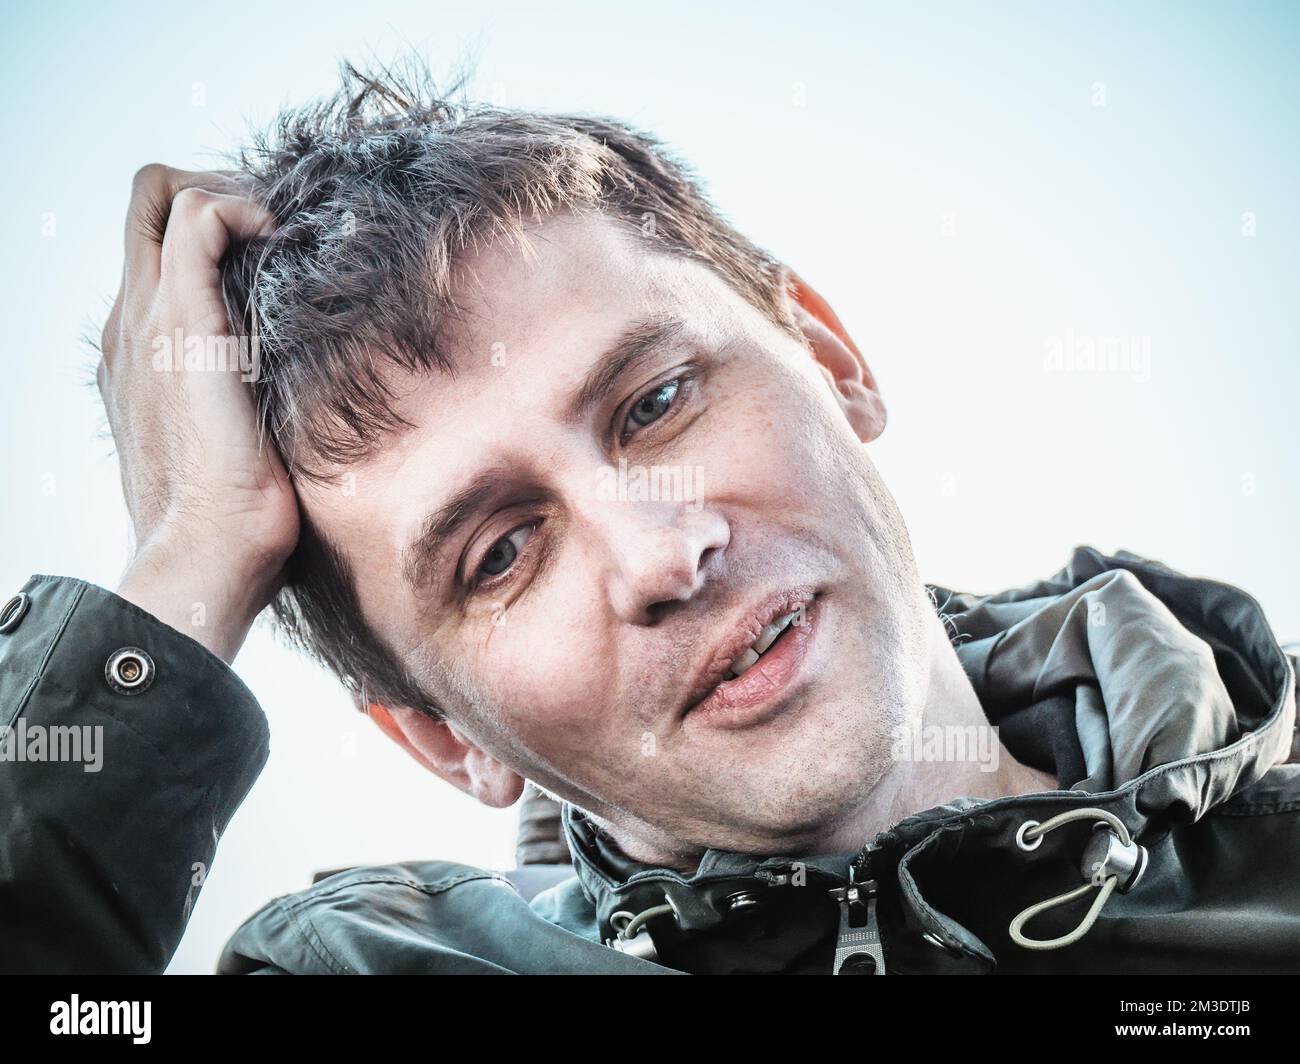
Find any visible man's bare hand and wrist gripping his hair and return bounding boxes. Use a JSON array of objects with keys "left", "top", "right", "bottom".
[{"left": 99, "top": 165, "right": 299, "bottom": 661}]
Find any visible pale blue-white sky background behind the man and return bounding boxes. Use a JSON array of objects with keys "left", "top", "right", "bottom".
[{"left": 0, "top": 0, "right": 1300, "bottom": 972}]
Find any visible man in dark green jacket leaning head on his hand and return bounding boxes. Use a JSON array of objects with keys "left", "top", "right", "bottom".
[{"left": 0, "top": 64, "right": 1300, "bottom": 974}]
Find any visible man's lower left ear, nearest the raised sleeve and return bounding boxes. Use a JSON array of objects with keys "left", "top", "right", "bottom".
[{"left": 365, "top": 702, "right": 524, "bottom": 809}]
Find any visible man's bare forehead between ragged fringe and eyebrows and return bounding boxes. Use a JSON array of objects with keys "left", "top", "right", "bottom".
[{"left": 302, "top": 215, "right": 766, "bottom": 606}]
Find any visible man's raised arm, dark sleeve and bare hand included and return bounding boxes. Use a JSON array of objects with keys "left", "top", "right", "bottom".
[{"left": 0, "top": 166, "right": 298, "bottom": 972}]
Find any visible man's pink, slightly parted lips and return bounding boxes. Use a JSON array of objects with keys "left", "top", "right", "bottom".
[{"left": 681, "top": 588, "right": 819, "bottom": 727}]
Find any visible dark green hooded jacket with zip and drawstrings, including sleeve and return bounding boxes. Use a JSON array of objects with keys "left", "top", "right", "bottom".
[{"left": 0, "top": 549, "right": 1300, "bottom": 973}]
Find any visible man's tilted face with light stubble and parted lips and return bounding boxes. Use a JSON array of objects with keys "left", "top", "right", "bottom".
[{"left": 303, "top": 216, "right": 930, "bottom": 851}]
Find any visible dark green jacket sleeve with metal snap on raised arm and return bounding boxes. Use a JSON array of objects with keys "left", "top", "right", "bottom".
[{"left": 0, "top": 576, "right": 269, "bottom": 973}]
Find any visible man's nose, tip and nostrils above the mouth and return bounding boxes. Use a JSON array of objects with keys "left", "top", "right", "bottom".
[{"left": 599, "top": 502, "right": 731, "bottom": 626}]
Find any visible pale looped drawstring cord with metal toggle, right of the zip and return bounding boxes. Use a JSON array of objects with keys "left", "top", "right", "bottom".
[{"left": 1008, "top": 808, "right": 1147, "bottom": 950}]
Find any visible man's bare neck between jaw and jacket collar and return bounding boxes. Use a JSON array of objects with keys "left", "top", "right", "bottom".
[{"left": 605, "top": 606, "right": 1057, "bottom": 871}]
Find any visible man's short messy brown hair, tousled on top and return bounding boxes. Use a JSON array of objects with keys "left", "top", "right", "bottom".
[{"left": 222, "top": 62, "right": 797, "bottom": 715}]
